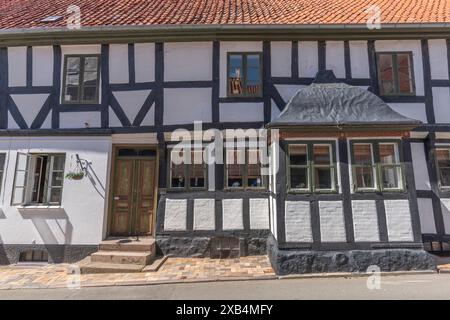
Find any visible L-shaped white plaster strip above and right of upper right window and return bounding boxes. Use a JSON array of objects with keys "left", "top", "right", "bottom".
[{"left": 375, "top": 40, "right": 425, "bottom": 96}]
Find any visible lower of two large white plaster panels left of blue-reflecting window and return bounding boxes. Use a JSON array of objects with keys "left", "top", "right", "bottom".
[{"left": 164, "top": 88, "right": 212, "bottom": 125}]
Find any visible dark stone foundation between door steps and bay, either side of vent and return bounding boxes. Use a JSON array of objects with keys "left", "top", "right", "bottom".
[{"left": 156, "top": 236, "right": 267, "bottom": 258}]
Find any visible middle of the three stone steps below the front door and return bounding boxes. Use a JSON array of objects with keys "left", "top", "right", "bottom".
[{"left": 91, "top": 250, "right": 154, "bottom": 266}]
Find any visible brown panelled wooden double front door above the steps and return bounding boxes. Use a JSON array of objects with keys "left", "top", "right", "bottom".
[{"left": 109, "top": 148, "right": 156, "bottom": 236}]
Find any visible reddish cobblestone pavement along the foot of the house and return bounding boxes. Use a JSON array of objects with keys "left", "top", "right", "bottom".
[{"left": 0, "top": 256, "right": 276, "bottom": 289}]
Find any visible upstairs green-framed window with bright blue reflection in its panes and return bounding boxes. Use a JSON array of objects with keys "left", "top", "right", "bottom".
[{"left": 227, "top": 52, "right": 263, "bottom": 97}]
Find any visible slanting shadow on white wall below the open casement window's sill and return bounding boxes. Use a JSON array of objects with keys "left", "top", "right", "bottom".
[{"left": 18, "top": 208, "right": 73, "bottom": 245}]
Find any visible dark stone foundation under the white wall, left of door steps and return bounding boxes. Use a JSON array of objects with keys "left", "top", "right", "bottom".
[{"left": 0, "top": 244, "right": 98, "bottom": 265}]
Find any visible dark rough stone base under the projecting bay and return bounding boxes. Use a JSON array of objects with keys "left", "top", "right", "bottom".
[{"left": 267, "top": 237, "right": 436, "bottom": 275}]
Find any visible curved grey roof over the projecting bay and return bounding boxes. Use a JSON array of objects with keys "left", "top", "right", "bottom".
[{"left": 267, "top": 83, "right": 421, "bottom": 128}]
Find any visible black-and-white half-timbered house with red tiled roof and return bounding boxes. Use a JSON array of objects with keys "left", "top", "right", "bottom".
[{"left": 0, "top": 0, "right": 450, "bottom": 274}]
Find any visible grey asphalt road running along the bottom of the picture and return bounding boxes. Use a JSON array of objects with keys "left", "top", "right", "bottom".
[{"left": 0, "top": 274, "right": 450, "bottom": 300}]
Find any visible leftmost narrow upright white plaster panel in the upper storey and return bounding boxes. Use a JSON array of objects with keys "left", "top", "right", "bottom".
[{"left": 8, "top": 47, "right": 27, "bottom": 87}]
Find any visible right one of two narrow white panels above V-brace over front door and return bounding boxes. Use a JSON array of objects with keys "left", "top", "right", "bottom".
[{"left": 134, "top": 43, "right": 155, "bottom": 83}]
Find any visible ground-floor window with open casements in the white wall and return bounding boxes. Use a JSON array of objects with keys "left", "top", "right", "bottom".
[{"left": 11, "top": 152, "right": 66, "bottom": 205}]
